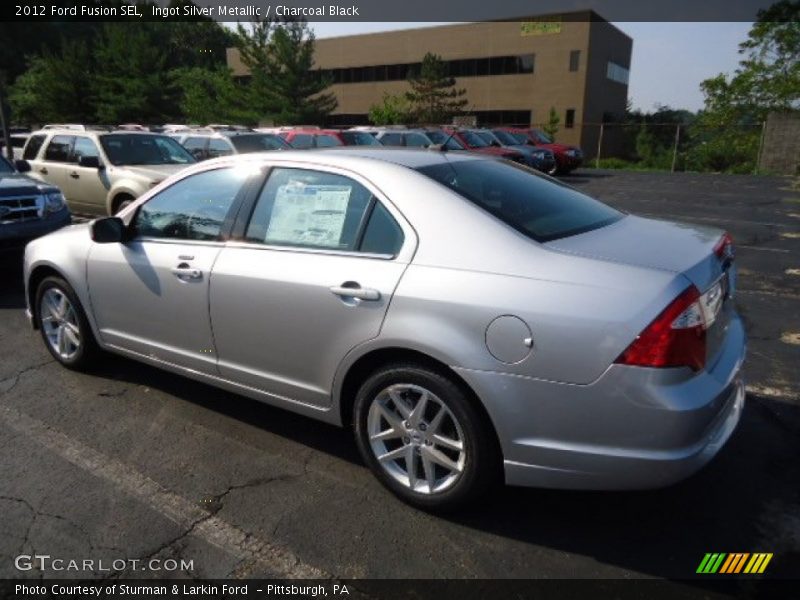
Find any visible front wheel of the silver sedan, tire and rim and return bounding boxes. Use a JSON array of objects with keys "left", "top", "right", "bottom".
[{"left": 36, "top": 277, "right": 98, "bottom": 370}]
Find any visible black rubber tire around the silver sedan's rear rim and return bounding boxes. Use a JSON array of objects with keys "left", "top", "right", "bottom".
[{"left": 353, "top": 363, "right": 502, "bottom": 512}]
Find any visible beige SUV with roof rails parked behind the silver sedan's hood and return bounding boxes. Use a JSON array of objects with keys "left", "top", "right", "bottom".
[{"left": 22, "top": 129, "right": 197, "bottom": 215}]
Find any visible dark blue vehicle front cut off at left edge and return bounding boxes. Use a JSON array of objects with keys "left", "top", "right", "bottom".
[{"left": 0, "top": 156, "right": 71, "bottom": 250}]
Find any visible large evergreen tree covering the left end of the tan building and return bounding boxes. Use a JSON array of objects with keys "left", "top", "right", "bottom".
[{"left": 237, "top": 19, "right": 337, "bottom": 123}]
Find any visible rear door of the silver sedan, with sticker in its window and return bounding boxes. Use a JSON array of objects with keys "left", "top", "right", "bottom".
[{"left": 210, "top": 167, "right": 416, "bottom": 407}]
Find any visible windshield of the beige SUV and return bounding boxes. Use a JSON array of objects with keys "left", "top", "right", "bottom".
[{"left": 100, "top": 133, "right": 197, "bottom": 166}]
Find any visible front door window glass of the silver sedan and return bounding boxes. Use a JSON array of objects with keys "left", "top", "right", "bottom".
[{"left": 135, "top": 169, "right": 250, "bottom": 240}]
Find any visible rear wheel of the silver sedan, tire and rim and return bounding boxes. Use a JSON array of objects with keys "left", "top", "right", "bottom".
[{"left": 354, "top": 364, "right": 501, "bottom": 510}]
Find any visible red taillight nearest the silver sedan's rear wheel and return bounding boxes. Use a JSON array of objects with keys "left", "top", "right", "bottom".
[{"left": 616, "top": 286, "right": 707, "bottom": 371}]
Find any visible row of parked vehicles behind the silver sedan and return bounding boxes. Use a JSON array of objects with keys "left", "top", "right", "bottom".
[{"left": 0, "top": 124, "right": 582, "bottom": 251}]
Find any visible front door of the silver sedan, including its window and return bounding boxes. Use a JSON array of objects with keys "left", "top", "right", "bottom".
[{"left": 87, "top": 167, "right": 251, "bottom": 374}]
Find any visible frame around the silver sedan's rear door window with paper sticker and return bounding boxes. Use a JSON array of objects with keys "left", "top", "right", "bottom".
[{"left": 226, "top": 159, "right": 419, "bottom": 264}]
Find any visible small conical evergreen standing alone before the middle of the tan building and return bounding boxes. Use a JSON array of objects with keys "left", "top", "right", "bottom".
[{"left": 406, "top": 52, "right": 468, "bottom": 123}]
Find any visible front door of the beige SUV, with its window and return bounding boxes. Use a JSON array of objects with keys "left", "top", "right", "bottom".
[{"left": 61, "top": 136, "right": 111, "bottom": 215}]
